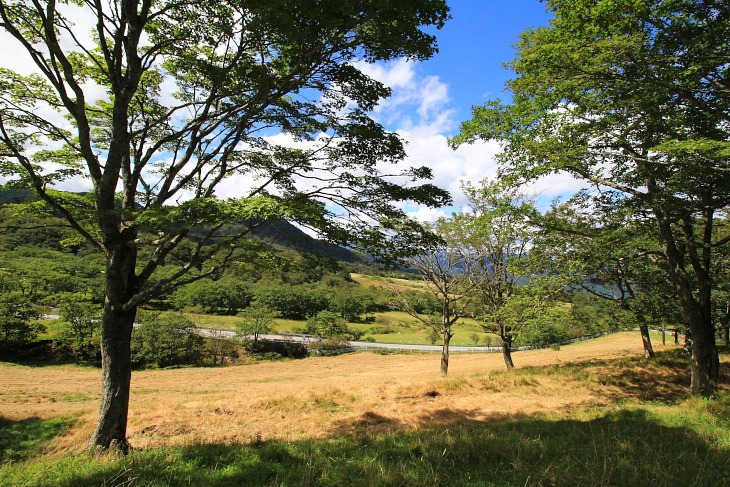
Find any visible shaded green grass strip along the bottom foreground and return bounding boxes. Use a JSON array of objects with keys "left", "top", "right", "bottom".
[{"left": 0, "top": 396, "right": 730, "bottom": 487}]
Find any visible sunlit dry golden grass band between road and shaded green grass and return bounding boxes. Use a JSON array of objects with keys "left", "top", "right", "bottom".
[{"left": 0, "top": 332, "right": 686, "bottom": 450}]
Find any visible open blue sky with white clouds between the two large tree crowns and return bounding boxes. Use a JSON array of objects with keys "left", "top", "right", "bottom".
[{"left": 336, "top": 0, "right": 579, "bottom": 221}]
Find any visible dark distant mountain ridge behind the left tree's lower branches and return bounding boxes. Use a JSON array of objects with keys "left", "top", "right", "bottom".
[{"left": 0, "top": 189, "right": 367, "bottom": 263}]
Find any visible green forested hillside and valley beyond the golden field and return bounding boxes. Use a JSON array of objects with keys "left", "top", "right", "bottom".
[{"left": 0, "top": 187, "right": 634, "bottom": 374}]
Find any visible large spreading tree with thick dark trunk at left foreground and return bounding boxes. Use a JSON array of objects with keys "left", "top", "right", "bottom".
[{"left": 0, "top": 0, "right": 448, "bottom": 451}]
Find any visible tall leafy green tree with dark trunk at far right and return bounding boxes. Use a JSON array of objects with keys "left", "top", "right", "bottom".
[{"left": 454, "top": 0, "right": 730, "bottom": 395}]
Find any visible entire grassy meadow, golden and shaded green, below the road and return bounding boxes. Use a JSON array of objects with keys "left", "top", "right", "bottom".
[{"left": 0, "top": 332, "right": 730, "bottom": 486}]
